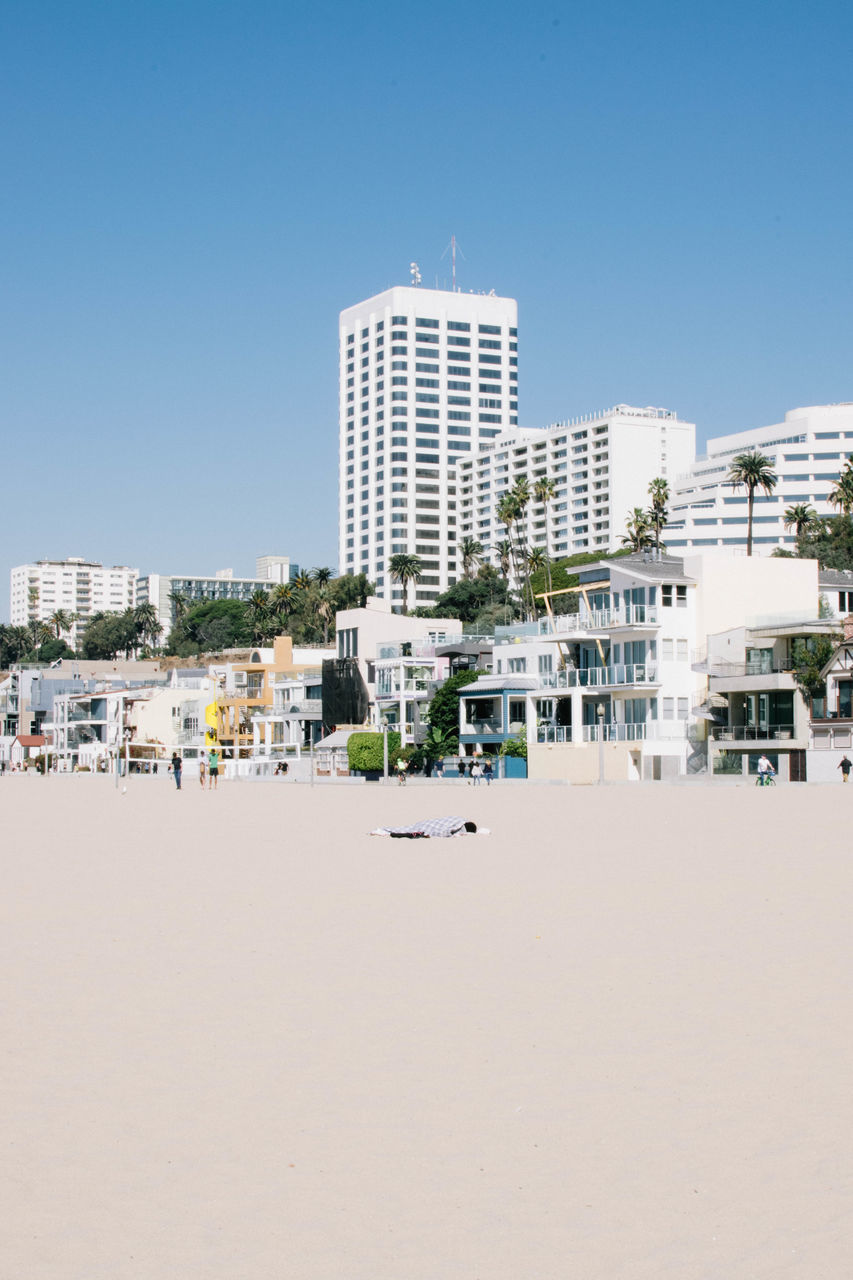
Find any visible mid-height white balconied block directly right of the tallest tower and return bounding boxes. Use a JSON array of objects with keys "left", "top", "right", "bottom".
[{"left": 456, "top": 404, "right": 695, "bottom": 564}]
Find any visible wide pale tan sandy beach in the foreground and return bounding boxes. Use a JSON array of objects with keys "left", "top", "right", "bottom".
[{"left": 0, "top": 777, "right": 853, "bottom": 1280}]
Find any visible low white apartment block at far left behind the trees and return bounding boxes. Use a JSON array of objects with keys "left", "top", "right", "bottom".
[{"left": 10, "top": 557, "right": 140, "bottom": 646}]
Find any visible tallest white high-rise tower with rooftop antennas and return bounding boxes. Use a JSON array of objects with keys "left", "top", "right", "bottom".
[{"left": 339, "top": 287, "right": 519, "bottom": 605}]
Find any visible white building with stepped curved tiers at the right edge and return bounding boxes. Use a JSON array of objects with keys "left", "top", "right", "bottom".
[{"left": 663, "top": 403, "right": 853, "bottom": 556}]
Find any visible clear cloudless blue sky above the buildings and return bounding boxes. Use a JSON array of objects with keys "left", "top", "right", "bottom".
[{"left": 0, "top": 0, "right": 853, "bottom": 618}]
